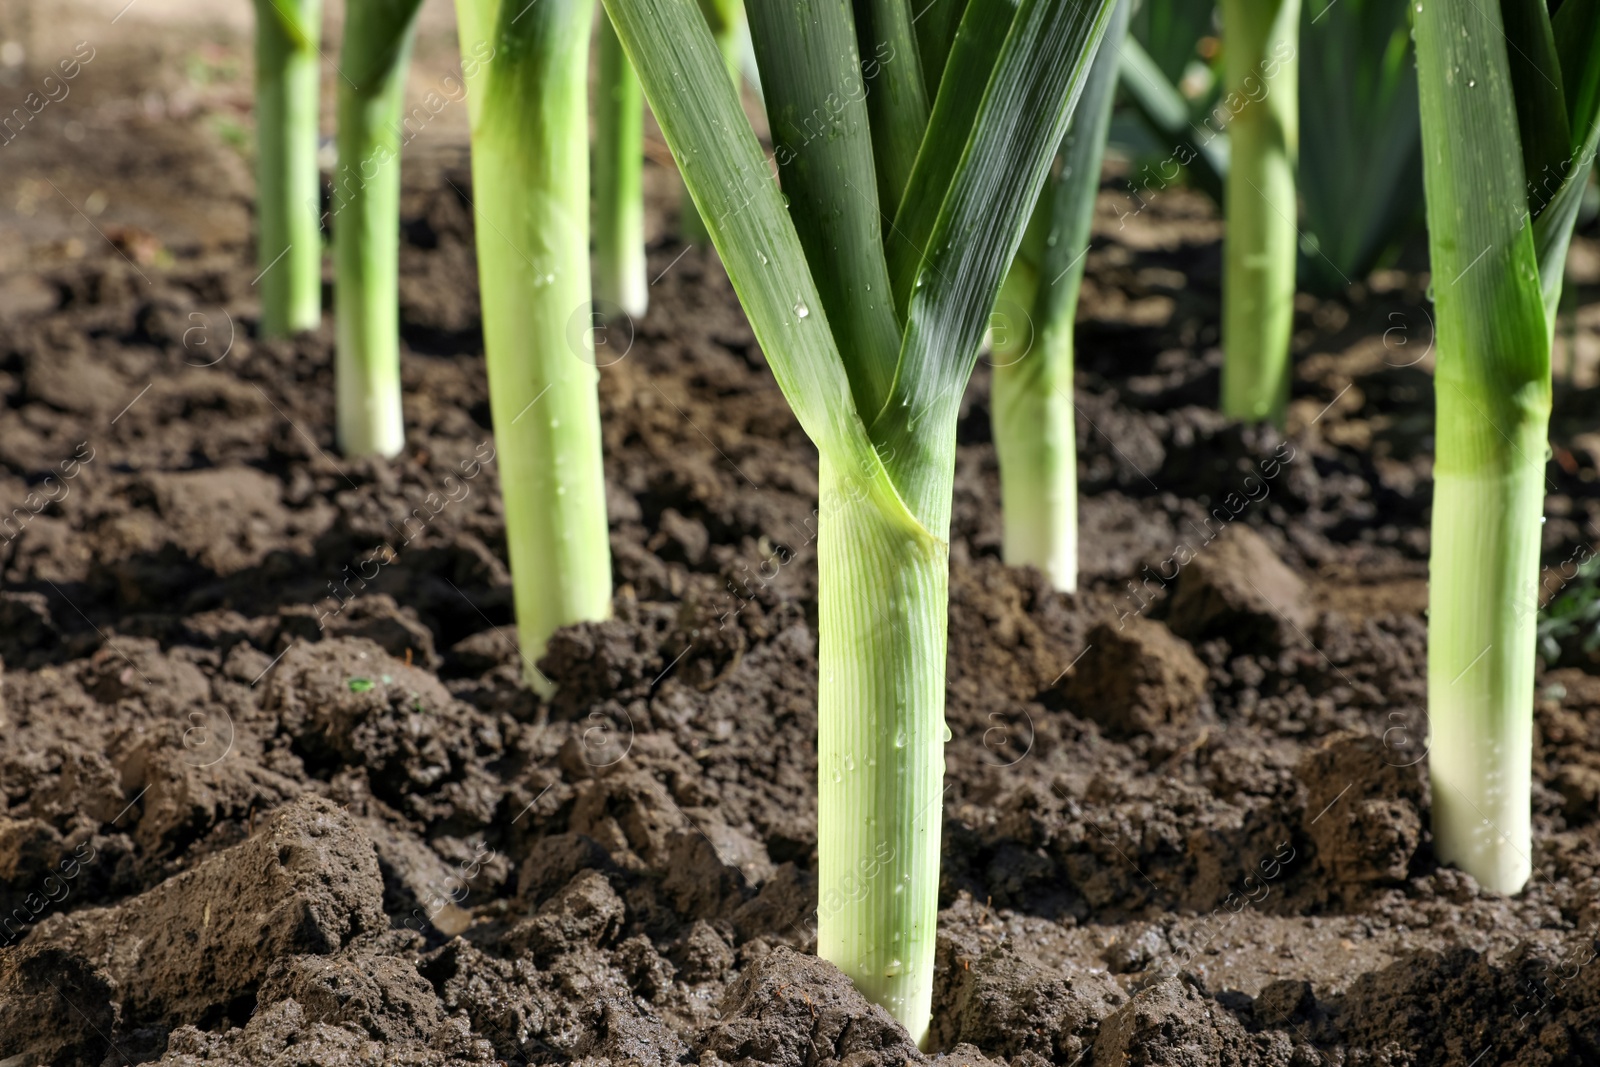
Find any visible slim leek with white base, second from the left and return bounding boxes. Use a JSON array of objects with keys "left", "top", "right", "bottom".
[{"left": 333, "top": 0, "right": 422, "bottom": 456}]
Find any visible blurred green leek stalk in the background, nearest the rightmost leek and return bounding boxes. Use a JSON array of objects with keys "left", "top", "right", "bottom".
[{"left": 1222, "top": 0, "right": 1299, "bottom": 422}]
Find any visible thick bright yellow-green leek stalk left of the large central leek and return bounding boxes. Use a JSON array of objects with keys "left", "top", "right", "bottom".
[{"left": 456, "top": 0, "right": 611, "bottom": 693}]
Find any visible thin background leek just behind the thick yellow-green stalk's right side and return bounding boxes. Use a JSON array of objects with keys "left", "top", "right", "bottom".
[{"left": 594, "top": 11, "right": 650, "bottom": 318}]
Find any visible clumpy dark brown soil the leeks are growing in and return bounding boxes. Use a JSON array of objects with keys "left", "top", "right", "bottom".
[{"left": 0, "top": 14, "right": 1600, "bottom": 1067}]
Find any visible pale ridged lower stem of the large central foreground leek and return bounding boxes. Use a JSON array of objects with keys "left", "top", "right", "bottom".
[{"left": 816, "top": 456, "right": 949, "bottom": 1037}]
